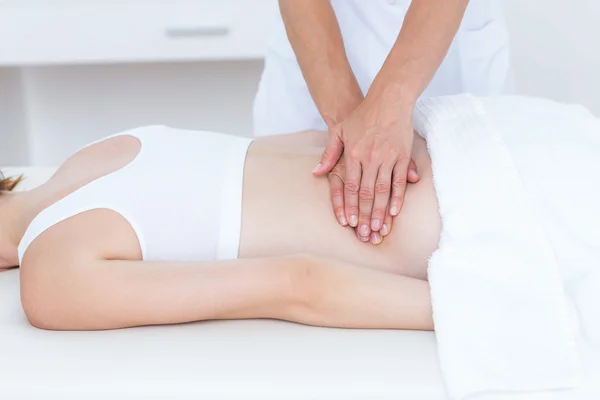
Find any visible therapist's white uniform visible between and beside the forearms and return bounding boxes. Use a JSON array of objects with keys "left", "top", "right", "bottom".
[{"left": 254, "top": 0, "right": 513, "bottom": 136}]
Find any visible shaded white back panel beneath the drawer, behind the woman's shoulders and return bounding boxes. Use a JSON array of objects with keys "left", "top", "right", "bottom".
[{"left": 23, "top": 61, "right": 262, "bottom": 165}]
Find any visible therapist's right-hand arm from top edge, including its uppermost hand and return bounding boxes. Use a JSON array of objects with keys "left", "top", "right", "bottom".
[{"left": 316, "top": 0, "right": 469, "bottom": 241}]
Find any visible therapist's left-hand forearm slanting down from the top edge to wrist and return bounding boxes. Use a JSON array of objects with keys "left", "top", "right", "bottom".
[{"left": 279, "top": 0, "right": 363, "bottom": 127}]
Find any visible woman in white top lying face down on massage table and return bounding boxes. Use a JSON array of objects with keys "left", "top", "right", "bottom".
[{"left": 0, "top": 123, "right": 440, "bottom": 330}]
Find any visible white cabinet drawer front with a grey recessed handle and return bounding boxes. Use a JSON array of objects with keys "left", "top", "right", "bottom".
[{"left": 0, "top": 0, "right": 277, "bottom": 65}]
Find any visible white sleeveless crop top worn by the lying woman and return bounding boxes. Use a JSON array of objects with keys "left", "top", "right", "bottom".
[{"left": 18, "top": 126, "right": 251, "bottom": 262}]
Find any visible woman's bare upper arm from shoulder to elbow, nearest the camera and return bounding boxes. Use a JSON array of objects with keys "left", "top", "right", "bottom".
[{"left": 22, "top": 252, "right": 310, "bottom": 330}]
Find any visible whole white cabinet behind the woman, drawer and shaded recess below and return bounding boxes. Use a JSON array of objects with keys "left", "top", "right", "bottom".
[{"left": 0, "top": 0, "right": 278, "bottom": 167}]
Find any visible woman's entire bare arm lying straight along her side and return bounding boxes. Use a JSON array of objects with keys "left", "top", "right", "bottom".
[{"left": 21, "top": 255, "right": 433, "bottom": 330}]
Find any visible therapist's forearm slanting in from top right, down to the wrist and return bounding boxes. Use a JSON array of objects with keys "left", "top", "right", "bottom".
[{"left": 367, "top": 0, "right": 469, "bottom": 108}]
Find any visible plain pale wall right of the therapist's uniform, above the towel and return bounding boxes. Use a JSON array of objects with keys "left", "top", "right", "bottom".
[{"left": 504, "top": 0, "right": 600, "bottom": 116}]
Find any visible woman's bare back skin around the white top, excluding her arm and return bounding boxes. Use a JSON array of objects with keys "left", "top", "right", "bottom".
[{"left": 19, "top": 130, "right": 440, "bottom": 278}]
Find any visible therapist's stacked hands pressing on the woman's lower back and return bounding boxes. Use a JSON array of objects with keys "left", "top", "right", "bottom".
[{"left": 314, "top": 97, "right": 419, "bottom": 242}]
